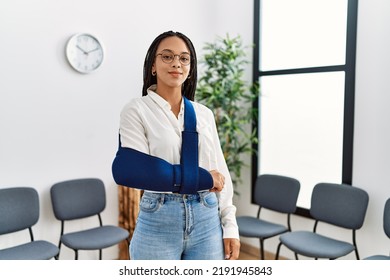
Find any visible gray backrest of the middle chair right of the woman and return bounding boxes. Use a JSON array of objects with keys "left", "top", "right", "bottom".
[{"left": 310, "top": 183, "right": 368, "bottom": 230}]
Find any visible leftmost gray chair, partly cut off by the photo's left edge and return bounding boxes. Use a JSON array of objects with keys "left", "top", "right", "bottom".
[{"left": 0, "top": 187, "right": 59, "bottom": 260}]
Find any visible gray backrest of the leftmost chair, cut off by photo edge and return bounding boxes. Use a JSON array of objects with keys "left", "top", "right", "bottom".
[{"left": 0, "top": 187, "right": 39, "bottom": 234}]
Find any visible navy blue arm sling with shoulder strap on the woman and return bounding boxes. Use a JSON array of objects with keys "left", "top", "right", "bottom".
[{"left": 112, "top": 97, "right": 213, "bottom": 194}]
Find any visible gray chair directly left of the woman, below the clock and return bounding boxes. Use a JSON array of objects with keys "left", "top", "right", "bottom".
[{"left": 50, "top": 178, "right": 129, "bottom": 260}]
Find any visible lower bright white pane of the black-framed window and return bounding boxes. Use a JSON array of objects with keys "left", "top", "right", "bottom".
[{"left": 258, "top": 72, "right": 344, "bottom": 209}]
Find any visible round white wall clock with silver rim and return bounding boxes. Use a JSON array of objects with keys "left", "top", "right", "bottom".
[{"left": 66, "top": 33, "right": 104, "bottom": 73}]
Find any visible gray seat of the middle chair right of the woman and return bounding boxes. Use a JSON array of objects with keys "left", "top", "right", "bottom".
[{"left": 280, "top": 231, "right": 355, "bottom": 259}]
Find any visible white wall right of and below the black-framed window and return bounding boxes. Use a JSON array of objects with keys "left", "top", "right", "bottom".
[{"left": 237, "top": 0, "right": 390, "bottom": 259}]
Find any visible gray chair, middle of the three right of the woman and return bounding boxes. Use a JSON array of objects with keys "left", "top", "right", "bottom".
[{"left": 276, "top": 183, "right": 368, "bottom": 259}]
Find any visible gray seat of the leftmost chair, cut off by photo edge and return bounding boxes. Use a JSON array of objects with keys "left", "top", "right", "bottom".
[{"left": 0, "top": 240, "right": 59, "bottom": 260}]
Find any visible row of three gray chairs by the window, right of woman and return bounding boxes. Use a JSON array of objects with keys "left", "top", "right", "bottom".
[{"left": 237, "top": 174, "right": 390, "bottom": 259}]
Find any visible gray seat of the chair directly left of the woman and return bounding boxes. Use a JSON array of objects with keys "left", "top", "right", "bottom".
[{"left": 61, "top": 226, "right": 129, "bottom": 250}]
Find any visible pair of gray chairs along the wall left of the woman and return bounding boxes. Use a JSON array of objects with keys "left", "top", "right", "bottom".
[{"left": 0, "top": 178, "right": 129, "bottom": 260}]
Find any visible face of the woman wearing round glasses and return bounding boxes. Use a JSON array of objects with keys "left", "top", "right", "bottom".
[{"left": 152, "top": 36, "right": 191, "bottom": 88}]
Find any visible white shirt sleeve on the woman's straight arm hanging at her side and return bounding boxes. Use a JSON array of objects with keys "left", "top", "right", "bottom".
[{"left": 210, "top": 111, "right": 239, "bottom": 239}]
